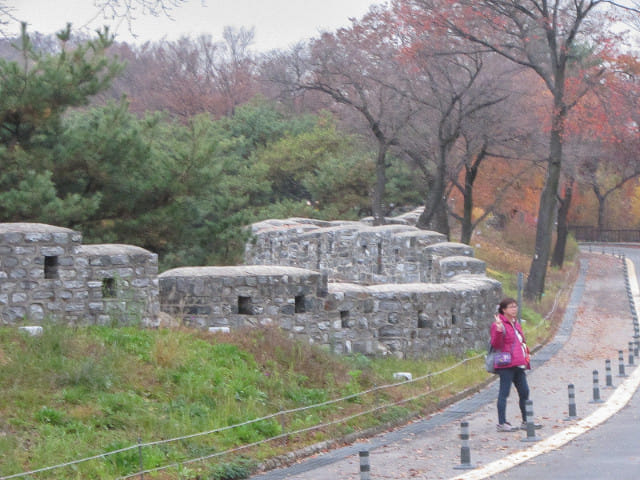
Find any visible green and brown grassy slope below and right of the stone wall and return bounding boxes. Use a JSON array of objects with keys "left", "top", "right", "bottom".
[{"left": 0, "top": 223, "right": 575, "bottom": 479}]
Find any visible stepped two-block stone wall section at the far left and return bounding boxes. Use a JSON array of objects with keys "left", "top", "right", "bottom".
[{"left": 0, "top": 223, "right": 159, "bottom": 324}]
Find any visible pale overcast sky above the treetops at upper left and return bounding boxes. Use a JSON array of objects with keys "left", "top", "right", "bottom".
[{"left": 6, "top": 0, "right": 383, "bottom": 50}]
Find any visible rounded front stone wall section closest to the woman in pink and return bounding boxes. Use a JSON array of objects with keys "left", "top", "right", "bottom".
[{"left": 323, "top": 275, "right": 501, "bottom": 358}]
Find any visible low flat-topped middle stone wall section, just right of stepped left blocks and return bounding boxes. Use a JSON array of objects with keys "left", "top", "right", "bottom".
[{"left": 159, "top": 265, "right": 327, "bottom": 336}]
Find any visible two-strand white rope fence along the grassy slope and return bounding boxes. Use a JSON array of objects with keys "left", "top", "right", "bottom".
[{"left": 0, "top": 354, "right": 484, "bottom": 480}]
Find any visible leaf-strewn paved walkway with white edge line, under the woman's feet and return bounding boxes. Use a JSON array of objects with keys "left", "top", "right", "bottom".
[{"left": 253, "top": 247, "right": 640, "bottom": 480}]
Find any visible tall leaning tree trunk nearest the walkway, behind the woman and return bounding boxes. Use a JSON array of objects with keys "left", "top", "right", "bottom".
[{"left": 524, "top": 92, "right": 567, "bottom": 300}]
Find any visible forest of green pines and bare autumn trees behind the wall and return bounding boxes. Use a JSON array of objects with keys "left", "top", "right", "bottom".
[{"left": 0, "top": 0, "right": 640, "bottom": 295}]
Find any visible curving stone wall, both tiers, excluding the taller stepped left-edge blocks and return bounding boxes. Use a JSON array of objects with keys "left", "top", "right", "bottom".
[{"left": 155, "top": 215, "right": 501, "bottom": 358}]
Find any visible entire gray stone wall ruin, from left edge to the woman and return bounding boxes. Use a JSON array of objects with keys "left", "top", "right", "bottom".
[{"left": 0, "top": 218, "right": 501, "bottom": 357}]
